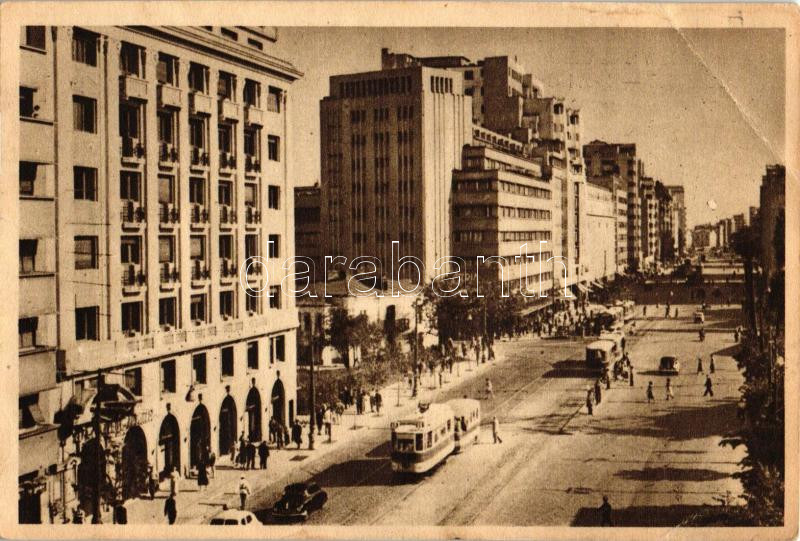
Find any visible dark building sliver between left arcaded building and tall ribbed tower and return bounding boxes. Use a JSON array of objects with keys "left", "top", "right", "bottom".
[{"left": 294, "top": 185, "right": 324, "bottom": 274}]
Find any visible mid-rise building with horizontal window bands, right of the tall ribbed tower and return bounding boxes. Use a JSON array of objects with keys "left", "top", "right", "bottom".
[{"left": 452, "top": 126, "right": 563, "bottom": 300}]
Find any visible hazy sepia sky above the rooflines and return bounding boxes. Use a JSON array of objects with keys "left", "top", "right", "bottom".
[{"left": 271, "top": 27, "right": 785, "bottom": 227}]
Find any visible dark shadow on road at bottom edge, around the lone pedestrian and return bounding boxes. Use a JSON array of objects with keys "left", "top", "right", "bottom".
[{"left": 570, "top": 502, "right": 732, "bottom": 527}]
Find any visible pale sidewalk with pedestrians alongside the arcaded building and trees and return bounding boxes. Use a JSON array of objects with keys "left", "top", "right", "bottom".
[{"left": 125, "top": 341, "right": 504, "bottom": 524}]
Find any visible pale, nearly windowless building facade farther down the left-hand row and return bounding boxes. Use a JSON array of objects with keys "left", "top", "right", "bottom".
[{"left": 584, "top": 177, "right": 618, "bottom": 281}]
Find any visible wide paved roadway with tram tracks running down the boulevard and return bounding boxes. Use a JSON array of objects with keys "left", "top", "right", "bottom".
[{"left": 253, "top": 306, "right": 741, "bottom": 526}]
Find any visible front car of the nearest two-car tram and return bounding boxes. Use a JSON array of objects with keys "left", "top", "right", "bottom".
[{"left": 391, "top": 404, "right": 455, "bottom": 473}]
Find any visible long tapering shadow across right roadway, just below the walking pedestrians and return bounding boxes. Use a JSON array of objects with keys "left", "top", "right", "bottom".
[{"left": 584, "top": 399, "right": 738, "bottom": 441}]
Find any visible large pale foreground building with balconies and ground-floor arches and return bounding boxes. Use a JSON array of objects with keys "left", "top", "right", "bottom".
[{"left": 19, "top": 26, "right": 301, "bottom": 522}]
